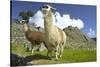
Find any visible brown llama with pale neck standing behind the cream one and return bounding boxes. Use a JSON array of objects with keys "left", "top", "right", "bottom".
[{"left": 24, "top": 23, "right": 46, "bottom": 54}]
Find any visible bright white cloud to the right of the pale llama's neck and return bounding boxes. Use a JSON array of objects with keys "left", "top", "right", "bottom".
[{"left": 56, "top": 12, "right": 84, "bottom": 29}]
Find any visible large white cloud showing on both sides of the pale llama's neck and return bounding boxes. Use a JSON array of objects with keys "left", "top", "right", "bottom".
[{"left": 29, "top": 10, "right": 84, "bottom": 29}]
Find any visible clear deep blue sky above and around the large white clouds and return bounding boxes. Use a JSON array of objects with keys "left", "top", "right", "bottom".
[{"left": 11, "top": 1, "right": 96, "bottom": 37}]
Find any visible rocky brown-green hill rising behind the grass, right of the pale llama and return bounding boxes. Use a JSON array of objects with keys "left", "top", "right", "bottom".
[{"left": 63, "top": 26, "right": 96, "bottom": 49}]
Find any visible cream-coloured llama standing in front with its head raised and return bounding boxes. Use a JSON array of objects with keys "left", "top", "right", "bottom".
[{"left": 41, "top": 5, "right": 66, "bottom": 60}]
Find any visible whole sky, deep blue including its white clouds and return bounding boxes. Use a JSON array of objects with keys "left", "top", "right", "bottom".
[{"left": 10, "top": 1, "right": 96, "bottom": 37}]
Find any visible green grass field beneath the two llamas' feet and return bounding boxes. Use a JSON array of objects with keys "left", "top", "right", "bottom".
[{"left": 11, "top": 44, "right": 96, "bottom": 65}]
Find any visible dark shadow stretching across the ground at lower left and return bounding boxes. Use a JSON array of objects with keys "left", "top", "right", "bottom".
[{"left": 10, "top": 54, "right": 49, "bottom": 66}]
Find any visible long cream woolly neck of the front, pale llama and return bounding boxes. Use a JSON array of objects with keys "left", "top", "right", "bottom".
[{"left": 44, "top": 12, "right": 54, "bottom": 33}]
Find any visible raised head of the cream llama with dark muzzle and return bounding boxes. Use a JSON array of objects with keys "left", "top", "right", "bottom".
[{"left": 41, "top": 5, "right": 56, "bottom": 16}]
